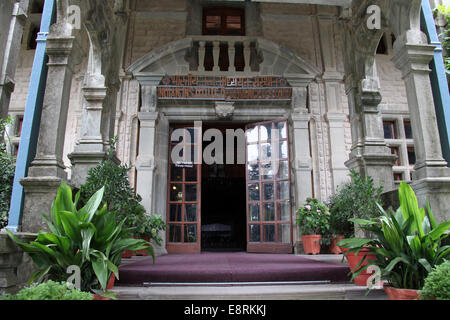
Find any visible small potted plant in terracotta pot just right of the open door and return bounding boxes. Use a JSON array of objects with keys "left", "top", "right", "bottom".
[{"left": 297, "top": 198, "right": 330, "bottom": 254}]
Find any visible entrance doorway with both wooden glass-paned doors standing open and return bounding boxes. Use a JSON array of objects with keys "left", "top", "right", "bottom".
[{"left": 166, "top": 120, "right": 293, "bottom": 253}]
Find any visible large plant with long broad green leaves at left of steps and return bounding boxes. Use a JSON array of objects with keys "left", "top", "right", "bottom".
[{"left": 7, "top": 183, "right": 155, "bottom": 291}]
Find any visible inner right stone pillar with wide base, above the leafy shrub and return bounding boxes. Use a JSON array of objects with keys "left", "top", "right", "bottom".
[{"left": 345, "top": 78, "right": 397, "bottom": 191}]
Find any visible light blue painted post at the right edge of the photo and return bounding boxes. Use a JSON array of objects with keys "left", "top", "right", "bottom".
[{"left": 422, "top": 0, "right": 450, "bottom": 166}]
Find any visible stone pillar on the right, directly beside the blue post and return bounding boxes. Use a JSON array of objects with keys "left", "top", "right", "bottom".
[{"left": 393, "top": 30, "right": 450, "bottom": 221}]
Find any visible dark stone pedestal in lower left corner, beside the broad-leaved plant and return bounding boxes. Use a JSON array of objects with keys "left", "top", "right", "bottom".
[{"left": 0, "top": 232, "right": 37, "bottom": 295}]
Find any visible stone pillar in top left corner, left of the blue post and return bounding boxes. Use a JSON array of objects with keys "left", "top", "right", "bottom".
[{"left": 0, "top": 0, "right": 28, "bottom": 120}]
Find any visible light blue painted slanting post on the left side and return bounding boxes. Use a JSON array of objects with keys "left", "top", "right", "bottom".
[{"left": 6, "top": 0, "right": 56, "bottom": 232}]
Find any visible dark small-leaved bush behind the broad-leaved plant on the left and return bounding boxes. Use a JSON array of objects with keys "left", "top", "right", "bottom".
[{"left": 80, "top": 138, "right": 145, "bottom": 236}]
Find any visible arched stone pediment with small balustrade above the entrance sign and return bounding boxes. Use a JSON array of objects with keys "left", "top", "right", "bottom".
[{"left": 127, "top": 36, "right": 321, "bottom": 86}]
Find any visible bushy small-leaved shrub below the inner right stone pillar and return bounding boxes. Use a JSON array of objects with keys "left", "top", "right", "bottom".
[{"left": 328, "top": 170, "right": 383, "bottom": 237}]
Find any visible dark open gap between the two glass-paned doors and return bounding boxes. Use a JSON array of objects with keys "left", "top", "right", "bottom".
[{"left": 201, "top": 125, "right": 247, "bottom": 252}]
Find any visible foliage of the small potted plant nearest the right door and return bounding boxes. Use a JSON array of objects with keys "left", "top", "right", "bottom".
[{"left": 297, "top": 198, "right": 330, "bottom": 235}]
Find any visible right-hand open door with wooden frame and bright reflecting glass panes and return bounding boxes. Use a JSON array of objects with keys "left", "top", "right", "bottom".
[{"left": 246, "top": 120, "right": 293, "bottom": 253}]
